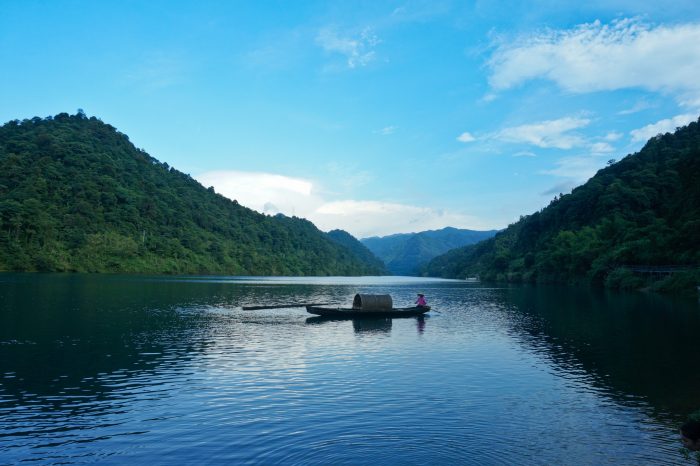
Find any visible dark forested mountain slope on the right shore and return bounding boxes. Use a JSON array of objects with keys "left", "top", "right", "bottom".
[{"left": 427, "top": 116, "right": 700, "bottom": 289}]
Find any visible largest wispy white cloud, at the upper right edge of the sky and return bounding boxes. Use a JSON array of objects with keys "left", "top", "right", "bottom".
[{"left": 488, "top": 19, "right": 700, "bottom": 104}]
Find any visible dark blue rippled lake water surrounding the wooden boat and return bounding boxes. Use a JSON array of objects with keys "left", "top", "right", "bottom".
[{"left": 0, "top": 274, "right": 700, "bottom": 465}]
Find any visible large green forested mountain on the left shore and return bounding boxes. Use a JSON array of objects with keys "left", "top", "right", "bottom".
[{"left": 0, "top": 111, "right": 382, "bottom": 275}]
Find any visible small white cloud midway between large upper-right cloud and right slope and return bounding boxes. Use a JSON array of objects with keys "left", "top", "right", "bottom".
[{"left": 492, "top": 117, "right": 590, "bottom": 149}]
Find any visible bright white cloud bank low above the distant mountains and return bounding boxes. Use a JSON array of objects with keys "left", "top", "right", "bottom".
[{"left": 196, "top": 171, "right": 482, "bottom": 238}]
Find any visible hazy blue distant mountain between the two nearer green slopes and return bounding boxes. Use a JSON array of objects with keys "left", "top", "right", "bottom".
[{"left": 361, "top": 227, "right": 496, "bottom": 276}]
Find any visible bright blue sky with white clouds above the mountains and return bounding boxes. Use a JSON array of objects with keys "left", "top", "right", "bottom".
[{"left": 0, "top": 0, "right": 700, "bottom": 238}]
